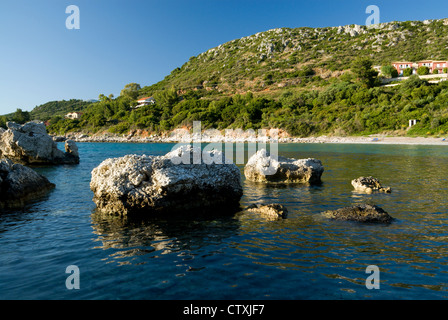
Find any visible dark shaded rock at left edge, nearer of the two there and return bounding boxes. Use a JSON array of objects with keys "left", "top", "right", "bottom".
[{"left": 0, "top": 159, "right": 55, "bottom": 209}]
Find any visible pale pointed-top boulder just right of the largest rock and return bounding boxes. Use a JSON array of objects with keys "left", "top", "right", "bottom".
[{"left": 244, "top": 149, "right": 324, "bottom": 183}]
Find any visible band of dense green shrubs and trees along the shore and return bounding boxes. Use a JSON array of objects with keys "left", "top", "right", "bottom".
[{"left": 34, "top": 76, "right": 448, "bottom": 136}]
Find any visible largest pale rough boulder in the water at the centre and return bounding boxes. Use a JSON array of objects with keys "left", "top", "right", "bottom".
[{"left": 90, "top": 145, "right": 243, "bottom": 214}]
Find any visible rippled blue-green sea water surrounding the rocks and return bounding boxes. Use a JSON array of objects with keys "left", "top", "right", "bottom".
[{"left": 0, "top": 143, "right": 448, "bottom": 300}]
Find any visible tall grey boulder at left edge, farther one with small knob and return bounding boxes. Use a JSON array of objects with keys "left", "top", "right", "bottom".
[{"left": 0, "top": 122, "right": 79, "bottom": 165}]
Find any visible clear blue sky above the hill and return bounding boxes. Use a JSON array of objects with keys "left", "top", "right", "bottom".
[{"left": 0, "top": 0, "right": 448, "bottom": 114}]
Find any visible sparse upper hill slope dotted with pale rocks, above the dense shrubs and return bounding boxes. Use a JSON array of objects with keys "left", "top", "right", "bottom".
[{"left": 144, "top": 19, "right": 448, "bottom": 94}]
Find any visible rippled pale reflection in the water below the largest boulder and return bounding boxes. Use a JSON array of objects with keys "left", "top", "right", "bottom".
[{"left": 92, "top": 212, "right": 239, "bottom": 264}]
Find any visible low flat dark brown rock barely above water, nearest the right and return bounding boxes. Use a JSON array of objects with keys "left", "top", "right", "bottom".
[{"left": 323, "top": 204, "right": 393, "bottom": 223}]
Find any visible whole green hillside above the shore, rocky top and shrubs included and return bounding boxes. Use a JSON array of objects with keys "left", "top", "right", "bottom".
[{"left": 2, "top": 19, "right": 448, "bottom": 137}]
